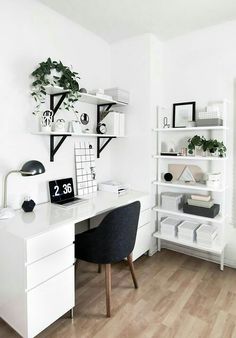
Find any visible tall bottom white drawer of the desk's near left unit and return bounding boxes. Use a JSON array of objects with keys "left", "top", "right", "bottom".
[{"left": 27, "top": 267, "right": 75, "bottom": 337}]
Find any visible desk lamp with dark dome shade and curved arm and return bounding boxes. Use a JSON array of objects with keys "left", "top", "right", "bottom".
[{"left": 0, "top": 160, "right": 45, "bottom": 219}]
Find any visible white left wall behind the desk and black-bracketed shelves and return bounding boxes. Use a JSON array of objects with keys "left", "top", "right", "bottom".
[{"left": 0, "top": 0, "right": 110, "bottom": 207}]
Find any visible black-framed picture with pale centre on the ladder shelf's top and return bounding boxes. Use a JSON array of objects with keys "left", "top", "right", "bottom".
[{"left": 173, "top": 102, "right": 196, "bottom": 128}]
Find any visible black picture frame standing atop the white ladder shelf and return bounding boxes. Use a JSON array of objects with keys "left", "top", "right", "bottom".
[{"left": 173, "top": 101, "right": 196, "bottom": 128}]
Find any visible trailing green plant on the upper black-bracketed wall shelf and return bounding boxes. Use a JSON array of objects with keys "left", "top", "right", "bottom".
[{"left": 31, "top": 58, "right": 80, "bottom": 114}]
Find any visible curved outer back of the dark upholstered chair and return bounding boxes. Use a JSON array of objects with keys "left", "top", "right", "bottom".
[{"left": 97, "top": 201, "right": 140, "bottom": 264}]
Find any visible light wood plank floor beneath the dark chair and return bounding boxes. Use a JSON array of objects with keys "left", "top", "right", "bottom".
[{"left": 0, "top": 250, "right": 236, "bottom": 338}]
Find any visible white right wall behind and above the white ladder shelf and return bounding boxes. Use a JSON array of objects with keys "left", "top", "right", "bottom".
[{"left": 163, "top": 21, "right": 236, "bottom": 266}]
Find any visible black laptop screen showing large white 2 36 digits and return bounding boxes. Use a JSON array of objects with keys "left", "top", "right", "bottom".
[{"left": 49, "top": 177, "right": 75, "bottom": 203}]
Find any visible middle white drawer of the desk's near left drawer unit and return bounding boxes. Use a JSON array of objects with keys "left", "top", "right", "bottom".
[{"left": 26, "top": 244, "right": 75, "bottom": 290}]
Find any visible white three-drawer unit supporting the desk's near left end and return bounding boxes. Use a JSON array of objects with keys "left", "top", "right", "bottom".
[{"left": 0, "top": 222, "right": 75, "bottom": 338}]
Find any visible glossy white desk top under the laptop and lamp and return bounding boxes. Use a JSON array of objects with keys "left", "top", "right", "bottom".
[{"left": 0, "top": 190, "right": 148, "bottom": 240}]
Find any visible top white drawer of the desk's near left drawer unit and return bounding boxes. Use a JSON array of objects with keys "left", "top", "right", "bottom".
[{"left": 26, "top": 223, "right": 74, "bottom": 263}]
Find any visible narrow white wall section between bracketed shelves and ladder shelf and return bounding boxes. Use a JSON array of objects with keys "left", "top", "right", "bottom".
[{"left": 111, "top": 34, "right": 161, "bottom": 191}]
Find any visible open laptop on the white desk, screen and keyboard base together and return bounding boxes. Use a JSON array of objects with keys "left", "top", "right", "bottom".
[{"left": 49, "top": 177, "right": 86, "bottom": 207}]
